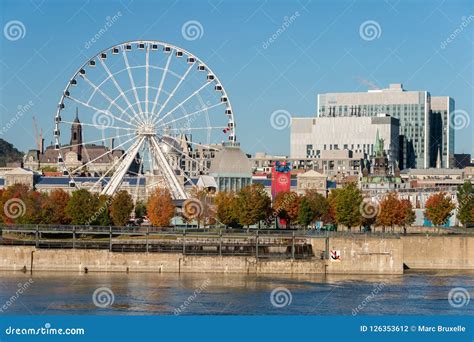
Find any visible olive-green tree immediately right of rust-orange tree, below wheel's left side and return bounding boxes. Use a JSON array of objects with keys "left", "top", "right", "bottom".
[{"left": 66, "top": 189, "right": 100, "bottom": 225}]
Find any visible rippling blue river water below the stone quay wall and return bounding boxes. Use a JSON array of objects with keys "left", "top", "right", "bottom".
[{"left": 0, "top": 271, "right": 474, "bottom": 315}]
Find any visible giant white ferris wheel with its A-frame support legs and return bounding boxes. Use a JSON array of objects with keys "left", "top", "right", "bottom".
[{"left": 54, "top": 40, "right": 236, "bottom": 199}]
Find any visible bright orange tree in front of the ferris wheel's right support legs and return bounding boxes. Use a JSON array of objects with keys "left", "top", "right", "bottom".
[{"left": 146, "top": 188, "right": 175, "bottom": 227}]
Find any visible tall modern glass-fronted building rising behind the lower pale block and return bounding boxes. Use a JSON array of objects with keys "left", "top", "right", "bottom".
[{"left": 317, "top": 83, "right": 454, "bottom": 168}]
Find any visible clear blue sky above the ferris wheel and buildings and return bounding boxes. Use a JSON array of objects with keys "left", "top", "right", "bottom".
[{"left": 0, "top": 0, "right": 474, "bottom": 154}]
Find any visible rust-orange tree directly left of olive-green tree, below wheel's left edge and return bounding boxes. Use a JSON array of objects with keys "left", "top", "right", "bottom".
[{"left": 41, "top": 189, "right": 71, "bottom": 224}]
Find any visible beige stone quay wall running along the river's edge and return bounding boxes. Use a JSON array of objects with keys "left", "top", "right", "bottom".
[{"left": 0, "top": 236, "right": 474, "bottom": 275}]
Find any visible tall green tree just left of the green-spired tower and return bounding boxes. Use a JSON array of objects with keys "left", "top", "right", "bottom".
[{"left": 336, "top": 183, "right": 362, "bottom": 229}]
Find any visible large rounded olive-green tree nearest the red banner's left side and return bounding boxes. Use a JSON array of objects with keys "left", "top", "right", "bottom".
[{"left": 235, "top": 184, "right": 271, "bottom": 227}]
